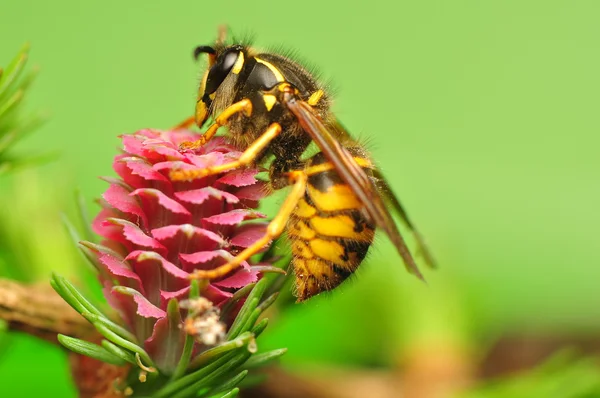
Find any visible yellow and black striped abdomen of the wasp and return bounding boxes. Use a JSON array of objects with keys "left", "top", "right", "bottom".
[{"left": 288, "top": 153, "right": 375, "bottom": 301}]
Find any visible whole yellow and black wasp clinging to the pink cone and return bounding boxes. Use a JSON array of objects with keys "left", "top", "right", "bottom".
[{"left": 170, "top": 31, "right": 434, "bottom": 302}]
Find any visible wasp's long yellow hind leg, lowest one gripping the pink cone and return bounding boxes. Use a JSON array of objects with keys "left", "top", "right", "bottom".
[{"left": 188, "top": 171, "right": 308, "bottom": 279}]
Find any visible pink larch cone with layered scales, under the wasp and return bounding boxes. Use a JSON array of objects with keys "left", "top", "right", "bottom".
[{"left": 82, "top": 130, "right": 266, "bottom": 374}]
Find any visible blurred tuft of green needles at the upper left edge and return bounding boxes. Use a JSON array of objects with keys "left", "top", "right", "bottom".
[{"left": 0, "top": 45, "right": 45, "bottom": 175}]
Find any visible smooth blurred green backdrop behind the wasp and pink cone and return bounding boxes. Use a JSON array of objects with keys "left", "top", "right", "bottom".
[{"left": 0, "top": 0, "right": 600, "bottom": 397}]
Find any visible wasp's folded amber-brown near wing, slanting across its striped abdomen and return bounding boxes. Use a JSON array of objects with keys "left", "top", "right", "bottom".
[{"left": 285, "top": 96, "right": 423, "bottom": 279}]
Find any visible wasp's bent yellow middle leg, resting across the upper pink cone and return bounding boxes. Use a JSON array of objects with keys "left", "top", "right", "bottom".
[{"left": 169, "top": 123, "right": 281, "bottom": 181}]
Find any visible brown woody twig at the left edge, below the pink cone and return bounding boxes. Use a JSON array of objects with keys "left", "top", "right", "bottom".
[{"left": 0, "top": 279, "right": 94, "bottom": 344}]
